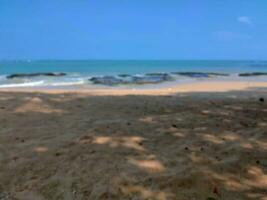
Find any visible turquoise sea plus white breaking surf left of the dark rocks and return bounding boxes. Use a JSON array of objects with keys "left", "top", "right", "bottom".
[{"left": 0, "top": 60, "right": 267, "bottom": 87}]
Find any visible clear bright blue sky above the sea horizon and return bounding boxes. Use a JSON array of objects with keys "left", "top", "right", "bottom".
[{"left": 0, "top": 0, "right": 267, "bottom": 59}]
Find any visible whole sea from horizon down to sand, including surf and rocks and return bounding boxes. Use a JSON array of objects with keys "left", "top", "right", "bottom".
[{"left": 0, "top": 60, "right": 267, "bottom": 88}]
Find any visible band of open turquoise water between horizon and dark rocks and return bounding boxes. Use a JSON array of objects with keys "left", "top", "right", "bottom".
[{"left": 0, "top": 60, "right": 267, "bottom": 75}]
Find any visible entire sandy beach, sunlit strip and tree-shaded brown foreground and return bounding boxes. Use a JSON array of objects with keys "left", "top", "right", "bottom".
[{"left": 0, "top": 82, "right": 267, "bottom": 200}]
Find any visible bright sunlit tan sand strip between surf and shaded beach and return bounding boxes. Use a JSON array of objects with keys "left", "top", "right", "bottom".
[{"left": 0, "top": 80, "right": 267, "bottom": 96}]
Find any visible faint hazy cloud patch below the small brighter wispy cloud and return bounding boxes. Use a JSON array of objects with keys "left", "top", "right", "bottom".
[{"left": 214, "top": 31, "right": 252, "bottom": 40}]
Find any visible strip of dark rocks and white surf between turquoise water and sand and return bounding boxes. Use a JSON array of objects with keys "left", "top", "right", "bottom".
[{"left": 0, "top": 71, "right": 267, "bottom": 90}]
